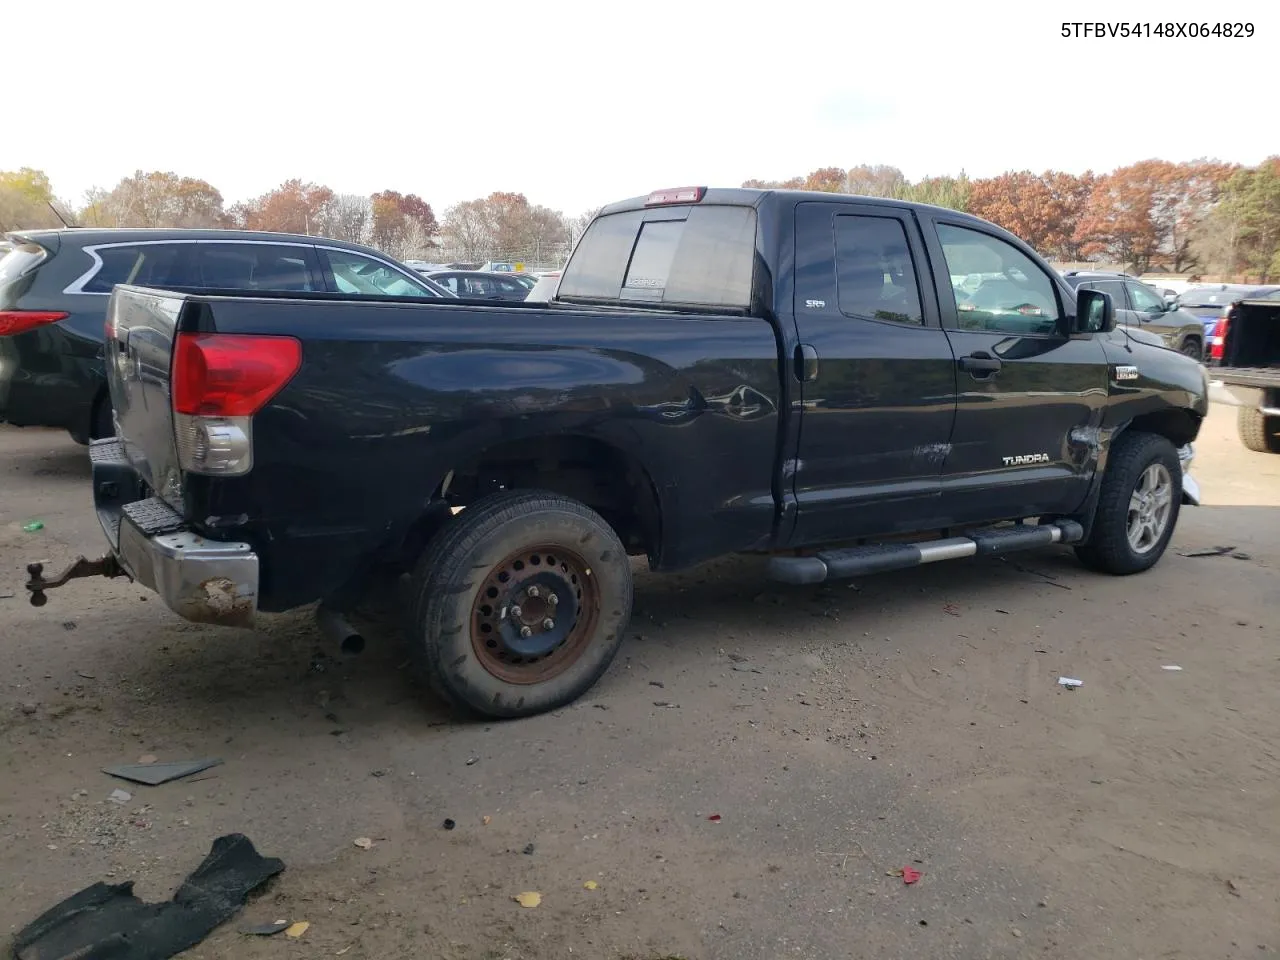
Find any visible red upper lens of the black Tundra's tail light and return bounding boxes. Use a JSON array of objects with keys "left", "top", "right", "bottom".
[{"left": 170, "top": 333, "right": 302, "bottom": 417}]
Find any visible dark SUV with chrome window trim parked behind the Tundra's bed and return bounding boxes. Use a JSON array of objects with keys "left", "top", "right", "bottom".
[{"left": 0, "top": 228, "right": 453, "bottom": 443}]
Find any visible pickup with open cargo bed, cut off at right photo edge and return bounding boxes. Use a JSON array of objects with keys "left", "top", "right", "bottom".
[{"left": 1208, "top": 287, "right": 1280, "bottom": 453}]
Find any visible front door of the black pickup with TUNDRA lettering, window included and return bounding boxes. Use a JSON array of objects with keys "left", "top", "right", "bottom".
[{"left": 923, "top": 215, "right": 1123, "bottom": 524}]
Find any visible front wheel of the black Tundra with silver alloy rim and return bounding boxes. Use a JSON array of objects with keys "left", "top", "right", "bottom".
[{"left": 1075, "top": 431, "right": 1183, "bottom": 576}]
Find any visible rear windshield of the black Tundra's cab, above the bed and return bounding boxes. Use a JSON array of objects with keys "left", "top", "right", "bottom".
[{"left": 558, "top": 206, "right": 755, "bottom": 308}]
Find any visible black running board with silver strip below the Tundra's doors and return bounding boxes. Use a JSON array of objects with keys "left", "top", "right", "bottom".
[{"left": 768, "top": 520, "right": 1084, "bottom": 585}]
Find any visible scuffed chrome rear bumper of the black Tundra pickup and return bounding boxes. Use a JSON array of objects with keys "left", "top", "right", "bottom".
[{"left": 90, "top": 439, "right": 259, "bottom": 627}]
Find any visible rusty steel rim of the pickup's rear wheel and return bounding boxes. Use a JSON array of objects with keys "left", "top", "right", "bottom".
[{"left": 471, "top": 544, "right": 600, "bottom": 684}]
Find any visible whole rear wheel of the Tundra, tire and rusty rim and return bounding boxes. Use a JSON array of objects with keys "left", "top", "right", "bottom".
[{"left": 407, "top": 490, "right": 632, "bottom": 718}]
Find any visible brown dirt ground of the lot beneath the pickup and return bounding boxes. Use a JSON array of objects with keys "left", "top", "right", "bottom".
[{"left": 0, "top": 406, "right": 1280, "bottom": 960}]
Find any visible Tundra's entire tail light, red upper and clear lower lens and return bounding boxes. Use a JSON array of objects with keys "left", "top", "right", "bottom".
[{"left": 170, "top": 333, "right": 302, "bottom": 476}]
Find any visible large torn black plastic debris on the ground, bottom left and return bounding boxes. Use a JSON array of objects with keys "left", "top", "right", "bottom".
[{"left": 14, "top": 833, "right": 284, "bottom": 960}]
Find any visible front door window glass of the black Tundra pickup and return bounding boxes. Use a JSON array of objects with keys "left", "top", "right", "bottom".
[{"left": 938, "top": 224, "right": 1060, "bottom": 335}]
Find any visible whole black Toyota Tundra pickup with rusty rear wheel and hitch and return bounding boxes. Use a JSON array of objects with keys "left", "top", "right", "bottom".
[{"left": 27, "top": 187, "right": 1207, "bottom": 717}]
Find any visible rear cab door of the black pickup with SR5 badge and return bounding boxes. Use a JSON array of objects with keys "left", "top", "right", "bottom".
[{"left": 787, "top": 201, "right": 956, "bottom": 545}]
